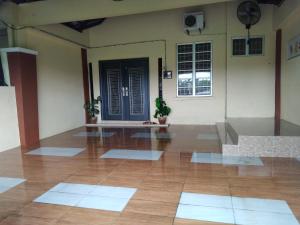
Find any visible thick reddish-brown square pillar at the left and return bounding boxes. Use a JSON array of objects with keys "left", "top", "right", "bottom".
[{"left": 7, "top": 52, "right": 40, "bottom": 150}]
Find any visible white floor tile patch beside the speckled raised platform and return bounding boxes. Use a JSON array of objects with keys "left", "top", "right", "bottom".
[{"left": 191, "top": 152, "right": 263, "bottom": 166}]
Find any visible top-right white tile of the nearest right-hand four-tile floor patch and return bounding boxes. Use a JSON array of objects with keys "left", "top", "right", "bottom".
[{"left": 232, "top": 197, "right": 293, "bottom": 214}]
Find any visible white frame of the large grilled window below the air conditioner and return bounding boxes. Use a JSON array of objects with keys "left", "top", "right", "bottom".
[{"left": 176, "top": 41, "right": 213, "bottom": 98}]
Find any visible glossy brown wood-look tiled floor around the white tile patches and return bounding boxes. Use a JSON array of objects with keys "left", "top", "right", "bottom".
[{"left": 0, "top": 126, "right": 300, "bottom": 225}]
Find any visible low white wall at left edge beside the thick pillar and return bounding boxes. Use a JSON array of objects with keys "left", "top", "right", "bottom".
[{"left": 0, "top": 87, "right": 20, "bottom": 152}]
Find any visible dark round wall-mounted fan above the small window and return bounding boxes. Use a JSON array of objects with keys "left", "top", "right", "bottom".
[{"left": 237, "top": 1, "right": 261, "bottom": 40}]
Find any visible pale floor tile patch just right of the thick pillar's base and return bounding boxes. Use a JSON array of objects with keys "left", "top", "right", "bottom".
[{"left": 26, "top": 147, "right": 84, "bottom": 157}]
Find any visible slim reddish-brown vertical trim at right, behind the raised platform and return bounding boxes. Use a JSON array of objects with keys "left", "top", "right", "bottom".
[{"left": 275, "top": 29, "right": 282, "bottom": 135}]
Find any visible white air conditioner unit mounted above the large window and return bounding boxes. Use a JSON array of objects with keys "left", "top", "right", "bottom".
[{"left": 183, "top": 12, "right": 205, "bottom": 35}]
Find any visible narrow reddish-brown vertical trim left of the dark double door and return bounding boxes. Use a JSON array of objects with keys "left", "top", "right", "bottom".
[{"left": 81, "top": 48, "right": 90, "bottom": 122}]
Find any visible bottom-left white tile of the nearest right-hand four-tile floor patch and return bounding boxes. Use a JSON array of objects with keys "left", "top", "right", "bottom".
[{"left": 176, "top": 204, "right": 234, "bottom": 224}]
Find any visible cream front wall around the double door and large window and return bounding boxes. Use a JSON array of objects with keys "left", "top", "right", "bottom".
[{"left": 88, "top": 4, "right": 226, "bottom": 124}]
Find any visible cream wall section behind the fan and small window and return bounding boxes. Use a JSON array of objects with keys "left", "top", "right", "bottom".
[{"left": 227, "top": 2, "right": 275, "bottom": 117}]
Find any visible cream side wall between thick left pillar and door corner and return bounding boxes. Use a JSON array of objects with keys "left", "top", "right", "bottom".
[{"left": 18, "top": 29, "right": 85, "bottom": 138}]
